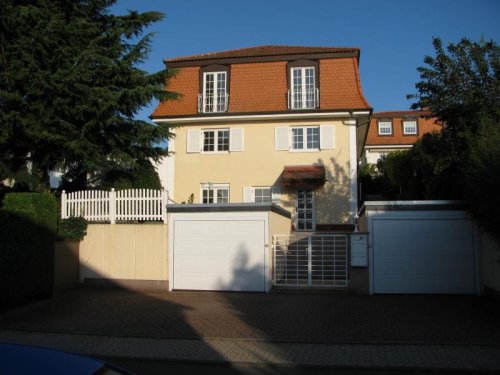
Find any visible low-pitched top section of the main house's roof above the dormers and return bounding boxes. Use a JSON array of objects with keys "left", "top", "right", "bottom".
[{"left": 164, "top": 45, "right": 359, "bottom": 63}]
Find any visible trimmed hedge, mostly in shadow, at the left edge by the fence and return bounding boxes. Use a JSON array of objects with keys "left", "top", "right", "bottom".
[{"left": 0, "top": 193, "right": 58, "bottom": 310}]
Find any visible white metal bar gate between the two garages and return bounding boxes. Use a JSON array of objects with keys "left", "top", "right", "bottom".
[{"left": 273, "top": 234, "right": 348, "bottom": 288}]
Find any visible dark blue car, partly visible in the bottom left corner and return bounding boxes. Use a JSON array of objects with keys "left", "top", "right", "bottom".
[{"left": 0, "top": 343, "right": 134, "bottom": 375}]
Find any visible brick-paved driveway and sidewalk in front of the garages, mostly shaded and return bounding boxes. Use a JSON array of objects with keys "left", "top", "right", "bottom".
[{"left": 0, "top": 289, "right": 500, "bottom": 373}]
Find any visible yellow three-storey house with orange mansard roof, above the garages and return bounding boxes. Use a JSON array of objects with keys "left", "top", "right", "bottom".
[{"left": 152, "top": 46, "right": 372, "bottom": 231}]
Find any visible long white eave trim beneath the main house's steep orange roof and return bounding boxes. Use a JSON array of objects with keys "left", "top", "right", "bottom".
[{"left": 153, "top": 111, "right": 356, "bottom": 124}]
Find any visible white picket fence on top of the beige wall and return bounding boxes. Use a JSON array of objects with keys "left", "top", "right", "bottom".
[{"left": 61, "top": 189, "right": 168, "bottom": 224}]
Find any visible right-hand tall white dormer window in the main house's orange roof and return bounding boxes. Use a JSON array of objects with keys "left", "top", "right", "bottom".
[{"left": 288, "top": 60, "right": 319, "bottom": 109}]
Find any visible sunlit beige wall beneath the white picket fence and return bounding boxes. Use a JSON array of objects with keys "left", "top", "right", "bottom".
[{"left": 80, "top": 224, "right": 168, "bottom": 282}]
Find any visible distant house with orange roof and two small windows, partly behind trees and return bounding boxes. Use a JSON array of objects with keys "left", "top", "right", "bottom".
[{"left": 364, "top": 111, "right": 442, "bottom": 164}]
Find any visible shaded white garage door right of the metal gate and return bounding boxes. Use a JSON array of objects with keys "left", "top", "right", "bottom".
[{"left": 372, "top": 218, "right": 476, "bottom": 294}]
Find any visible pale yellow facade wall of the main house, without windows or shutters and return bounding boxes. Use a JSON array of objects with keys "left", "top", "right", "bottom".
[{"left": 171, "top": 119, "right": 352, "bottom": 228}]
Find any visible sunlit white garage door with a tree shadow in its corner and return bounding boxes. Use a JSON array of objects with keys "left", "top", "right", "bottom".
[{"left": 173, "top": 220, "right": 266, "bottom": 292}]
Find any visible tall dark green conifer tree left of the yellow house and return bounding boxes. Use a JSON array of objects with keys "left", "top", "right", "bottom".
[{"left": 0, "top": 0, "right": 176, "bottom": 191}]
